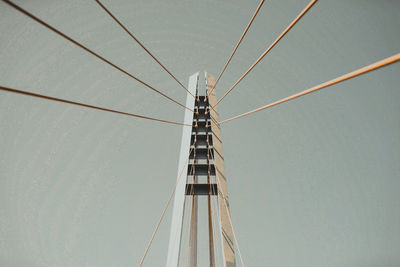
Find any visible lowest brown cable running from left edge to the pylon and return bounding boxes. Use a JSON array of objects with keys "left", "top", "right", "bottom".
[{"left": 0, "top": 86, "right": 192, "bottom": 126}]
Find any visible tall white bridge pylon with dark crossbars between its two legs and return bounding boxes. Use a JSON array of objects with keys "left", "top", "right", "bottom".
[{"left": 166, "top": 73, "right": 236, "bottom": 267}]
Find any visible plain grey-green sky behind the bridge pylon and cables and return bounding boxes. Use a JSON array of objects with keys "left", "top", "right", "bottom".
[{"left": 0, "top": 0, "right": 400, "bottom": 267}]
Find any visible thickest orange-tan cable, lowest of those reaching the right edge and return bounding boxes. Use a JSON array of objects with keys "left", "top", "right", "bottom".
[{"left": 219, "top": 53, "right": 400, "bottom": 124}]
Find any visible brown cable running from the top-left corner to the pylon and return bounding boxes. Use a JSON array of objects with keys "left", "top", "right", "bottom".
[{"left": 2, "top": 0, "right": 193, "bottom": 112}]
